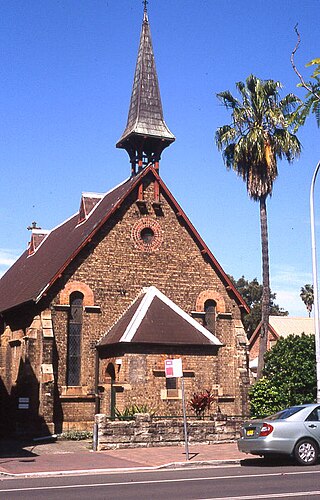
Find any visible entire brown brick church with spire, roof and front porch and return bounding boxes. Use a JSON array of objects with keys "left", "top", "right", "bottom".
[{"left": 0, "top": 3, "right": 249, "bottom": 434}]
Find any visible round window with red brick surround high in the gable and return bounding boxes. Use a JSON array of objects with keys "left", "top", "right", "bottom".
[{"left": 131, "top": 217, "right": 162, "bottom": 252}]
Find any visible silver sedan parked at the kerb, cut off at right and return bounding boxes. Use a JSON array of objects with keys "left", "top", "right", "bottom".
[{"left": 238, "top": 404, "right": 320, "bottom": 465}]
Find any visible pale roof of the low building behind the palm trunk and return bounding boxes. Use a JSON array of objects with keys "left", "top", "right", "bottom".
[{"left": 250, "top": 316, "right": 314, "bottom": 346}]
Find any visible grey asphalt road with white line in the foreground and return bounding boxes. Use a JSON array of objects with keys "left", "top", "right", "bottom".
[{"left": 0, "top": 465, "right": 320, "bottom": 500}]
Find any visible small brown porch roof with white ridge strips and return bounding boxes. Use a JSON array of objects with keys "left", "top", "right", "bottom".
[{"left": 98, "top": 286, "right": 223, "bottom": 348}]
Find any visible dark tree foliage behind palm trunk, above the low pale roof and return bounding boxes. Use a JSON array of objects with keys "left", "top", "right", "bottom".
[{"left": 230, "top": 276, "right": 289, "bottom": 339}]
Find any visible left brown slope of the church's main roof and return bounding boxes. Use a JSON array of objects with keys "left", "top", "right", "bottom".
[{"left": 0, "top": 175, "right": 139, "bottom": 312}]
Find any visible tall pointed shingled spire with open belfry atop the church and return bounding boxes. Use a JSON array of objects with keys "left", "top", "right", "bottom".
[{"left": 116, "top": 1, "right": 175, "bottom": 175}]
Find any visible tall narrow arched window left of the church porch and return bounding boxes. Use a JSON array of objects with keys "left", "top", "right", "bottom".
[{"left": 67, "top": 292, "right": 83, "bottom": 386}]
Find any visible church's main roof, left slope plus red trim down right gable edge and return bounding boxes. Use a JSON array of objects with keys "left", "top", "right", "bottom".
[{"left": 0, "top": 165, "right": 249, "bottom": 312}]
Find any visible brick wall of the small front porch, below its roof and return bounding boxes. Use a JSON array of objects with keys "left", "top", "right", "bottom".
[{"left": 100, "top": 347, "right": 220, "bottom": 416}]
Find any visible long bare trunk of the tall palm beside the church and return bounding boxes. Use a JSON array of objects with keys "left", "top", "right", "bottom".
[{"left": 257, "top": 196, "right": 270, "bottom": 379}]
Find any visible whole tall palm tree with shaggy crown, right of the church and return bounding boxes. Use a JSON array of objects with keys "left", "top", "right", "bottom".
[{"left": 215, "top": 75, "right": 301, "bottom": 377}]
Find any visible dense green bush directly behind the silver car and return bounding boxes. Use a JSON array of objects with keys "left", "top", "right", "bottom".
[{"left": 250, "top": 334, "right": 317, "bottom": 417}]
